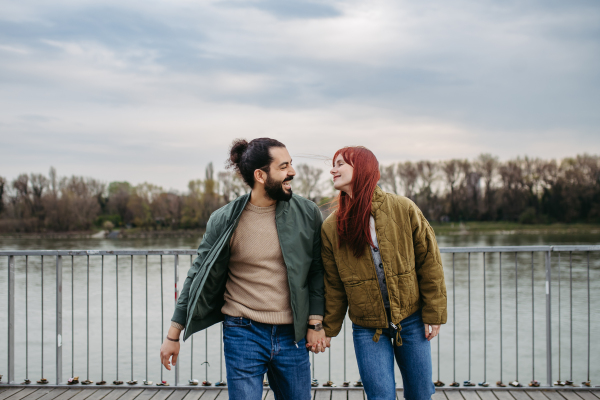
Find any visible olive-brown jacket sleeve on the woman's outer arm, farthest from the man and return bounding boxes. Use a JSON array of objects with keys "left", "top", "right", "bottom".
[{"left": 410, "top": 205, "right": 447, "bottom": 325}]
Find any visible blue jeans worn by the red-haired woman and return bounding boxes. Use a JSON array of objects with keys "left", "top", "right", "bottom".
[{"left": 352, "top": 310, "right": 435, "bottom": 400}]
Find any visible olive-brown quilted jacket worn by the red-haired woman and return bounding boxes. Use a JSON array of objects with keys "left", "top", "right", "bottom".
[{"left": 321, "top": 187, "right": 446, "bottom": 337}]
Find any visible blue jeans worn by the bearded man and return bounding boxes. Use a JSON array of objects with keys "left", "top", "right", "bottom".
[{"left": 223, "top": 315, "right": 311, "bottom": 400}]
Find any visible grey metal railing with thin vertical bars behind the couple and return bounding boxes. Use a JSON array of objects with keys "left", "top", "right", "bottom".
[{"left": 0, "top": 246, "right": 600, "bottom": 387}]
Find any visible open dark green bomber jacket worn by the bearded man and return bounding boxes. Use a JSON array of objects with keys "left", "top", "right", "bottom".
[{"left": 171, "top": 194, "right": 325, "bottom": 342}]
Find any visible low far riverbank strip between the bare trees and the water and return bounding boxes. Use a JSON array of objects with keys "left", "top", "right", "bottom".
[{"left": 0, "top": 222, "right": 600, "bottom": 239}]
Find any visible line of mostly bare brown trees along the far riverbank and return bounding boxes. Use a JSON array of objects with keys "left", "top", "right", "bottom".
[{"left": 0, "top": 154, "right": 600, "bottom": 233}]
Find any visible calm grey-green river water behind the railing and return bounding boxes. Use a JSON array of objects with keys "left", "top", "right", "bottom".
[{"left": 0, "top": 234, "right": 600, "bottom": 385}]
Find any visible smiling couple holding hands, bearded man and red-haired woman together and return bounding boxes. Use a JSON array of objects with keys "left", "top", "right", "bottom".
[{"left": 160, "top": 138, "right": 446, "bottom": 400}]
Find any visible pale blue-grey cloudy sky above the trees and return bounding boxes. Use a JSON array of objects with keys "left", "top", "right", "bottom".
[{"left": 0, "top": 0, "right": 600, "bottom": 191}]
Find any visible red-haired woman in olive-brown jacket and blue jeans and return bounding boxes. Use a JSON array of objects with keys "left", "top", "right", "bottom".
[{"left": 321, "top": 147, "right": 446, "bottom": 400}]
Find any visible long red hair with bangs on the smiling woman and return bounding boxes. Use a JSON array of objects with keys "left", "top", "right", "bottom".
[{"left": 333, "top": 146, "right": 381, "bottom": 258}]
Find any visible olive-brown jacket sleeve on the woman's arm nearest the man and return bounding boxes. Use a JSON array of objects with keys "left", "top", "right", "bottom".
[{"left": 321, "top": 230, "right": 348, "bottom": 337}]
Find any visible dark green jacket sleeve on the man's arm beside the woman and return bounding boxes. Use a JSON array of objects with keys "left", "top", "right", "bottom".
[{"left": 308, "top": 205, "right": 325, "bottom": 316}]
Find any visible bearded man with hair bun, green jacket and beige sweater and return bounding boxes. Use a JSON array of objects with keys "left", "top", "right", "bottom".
[{"left": 160, "top": 138, "right": 325, "bottom": 400}]
